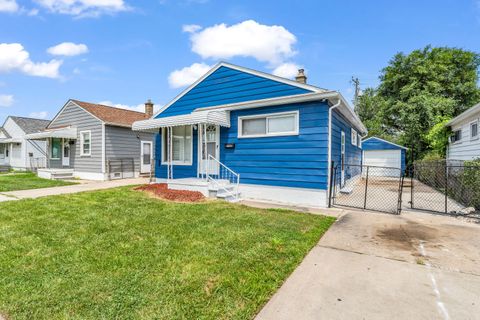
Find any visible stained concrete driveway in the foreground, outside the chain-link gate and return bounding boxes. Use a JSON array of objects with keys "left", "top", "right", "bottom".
[{"left": 257, "top": 211, "right": 480, "bottom": 320}]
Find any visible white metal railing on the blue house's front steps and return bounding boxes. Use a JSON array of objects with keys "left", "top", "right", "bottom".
[{"left": 206, "top": 155, "right": 240, "bottom": 200}]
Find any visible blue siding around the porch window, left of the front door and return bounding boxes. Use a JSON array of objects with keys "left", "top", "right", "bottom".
[{"left": 155, "top": 129, "right": 198, "bottom": 179}]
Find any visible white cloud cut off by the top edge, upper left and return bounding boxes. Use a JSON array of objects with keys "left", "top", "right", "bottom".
[{"left": 35, "top": 0, "right": 129, "bottom": 17}]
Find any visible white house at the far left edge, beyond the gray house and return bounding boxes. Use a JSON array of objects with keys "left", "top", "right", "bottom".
[{"left": 0, "top": 116, "right": 50, "bottom": 170}]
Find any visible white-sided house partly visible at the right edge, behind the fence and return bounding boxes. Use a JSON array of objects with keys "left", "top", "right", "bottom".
[{"left": 446, "top": 103, "right": 480, "bottom": 160}]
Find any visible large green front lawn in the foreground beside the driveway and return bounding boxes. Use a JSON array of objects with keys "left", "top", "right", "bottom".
[{"left": 0, "top": 187, "right": 334, "bottom": 319}]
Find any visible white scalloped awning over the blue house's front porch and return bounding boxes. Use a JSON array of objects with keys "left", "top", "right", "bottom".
[{"left": 132, "top": 110, "right": 230, "bottom": 132}]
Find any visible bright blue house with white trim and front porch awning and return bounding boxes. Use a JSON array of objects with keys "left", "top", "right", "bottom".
[{"left": 133, "top": 62, "right": 367, "bottom": 207}]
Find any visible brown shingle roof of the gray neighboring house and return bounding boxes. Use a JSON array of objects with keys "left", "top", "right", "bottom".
[{"left": 72, "top": 100, "right": 149, "bottom": 127}]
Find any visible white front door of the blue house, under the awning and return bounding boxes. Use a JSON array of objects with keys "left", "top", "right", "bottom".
[{"left": 198, "top": 124, "right": 220, "bottom": 175}]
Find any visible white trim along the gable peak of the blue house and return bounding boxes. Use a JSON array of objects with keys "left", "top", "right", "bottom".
[{"left": 152, "top": 62, "right": 326, "bottom": 118}]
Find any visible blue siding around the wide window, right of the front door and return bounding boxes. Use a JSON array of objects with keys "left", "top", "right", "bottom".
[{"left": 220, "top": 102, "right": 328, "bottom": 190}]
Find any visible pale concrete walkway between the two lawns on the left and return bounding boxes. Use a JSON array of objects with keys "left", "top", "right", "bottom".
[{"left": 0, "top": 178, "right": 149, "bottom": 202}]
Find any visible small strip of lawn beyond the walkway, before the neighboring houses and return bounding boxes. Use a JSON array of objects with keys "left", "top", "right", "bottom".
[{"left": 0, "top": 172, "right": 75, "bottom": 192}]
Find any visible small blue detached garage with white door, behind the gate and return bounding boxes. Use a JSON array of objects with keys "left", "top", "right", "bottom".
[{"left": 362, "top": 137, "right": 407, "bottom": 175}]
